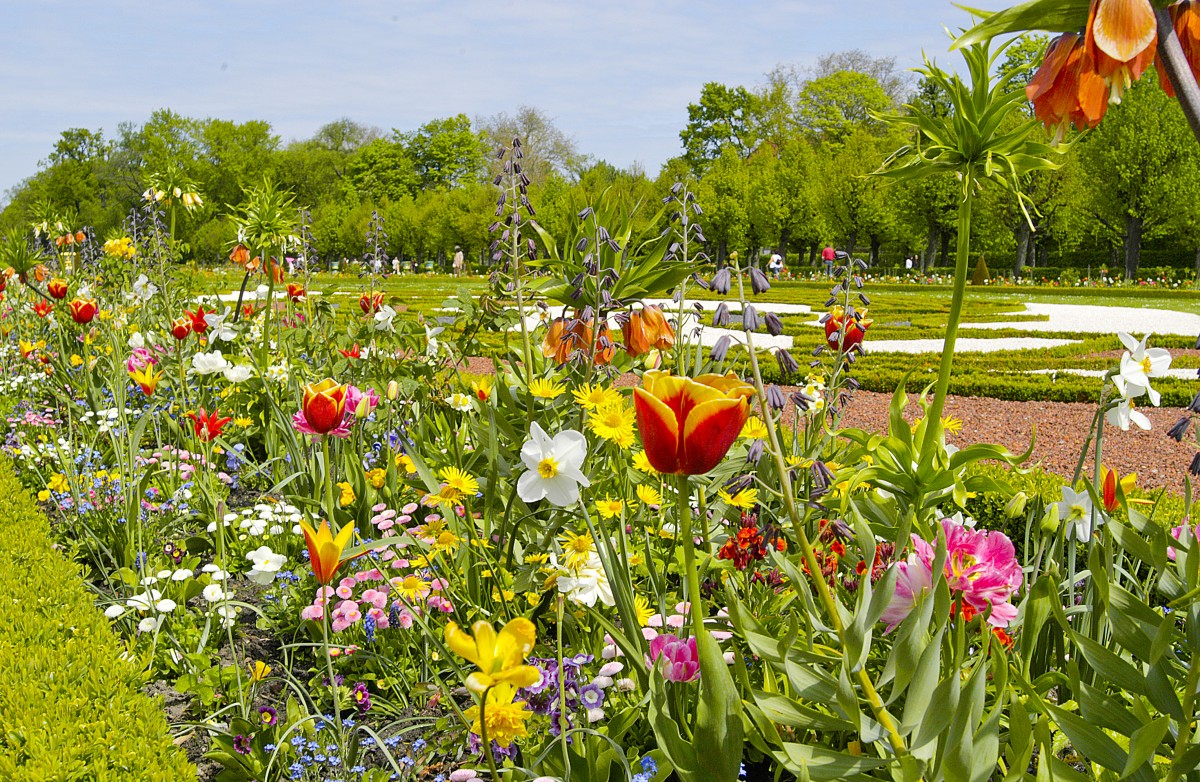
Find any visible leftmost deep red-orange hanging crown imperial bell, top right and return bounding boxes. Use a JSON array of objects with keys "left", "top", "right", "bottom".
[{"left": 1025, "top": 32, "right": 1109, "bottom": 139}]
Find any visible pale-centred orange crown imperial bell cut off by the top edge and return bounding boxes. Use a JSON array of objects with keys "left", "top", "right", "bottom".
[{"left": 1085, "top": 0, "right": 1158, "bottom": 103}]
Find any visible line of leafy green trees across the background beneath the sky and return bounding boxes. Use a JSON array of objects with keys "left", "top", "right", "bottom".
[{"left": 7, "top": 36, "right": 1200, "bottom": 277}]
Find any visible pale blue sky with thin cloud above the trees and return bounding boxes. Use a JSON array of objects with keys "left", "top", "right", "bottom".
[{"left": 0, "top": 0, "right": 967, "bottom": 196}]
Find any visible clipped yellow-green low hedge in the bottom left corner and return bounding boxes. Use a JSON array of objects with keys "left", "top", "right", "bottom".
[{"left": 0, "top": 459, "right": 196, "bottom": 782}]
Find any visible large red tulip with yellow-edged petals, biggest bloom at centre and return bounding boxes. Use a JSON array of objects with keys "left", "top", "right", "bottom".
[{"left": 634, "top": 371, "right": 754, "bottom": 475}]
